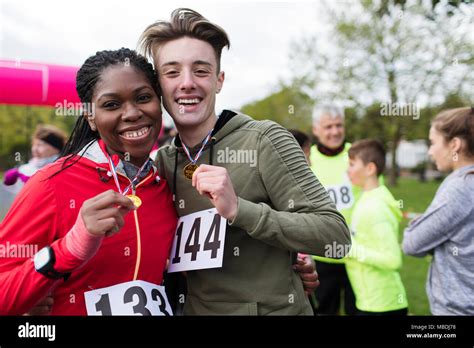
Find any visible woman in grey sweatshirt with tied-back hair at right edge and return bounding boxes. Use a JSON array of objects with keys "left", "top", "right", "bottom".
[{"left": 402, "top": 107, "right": 474, "bottom": 315}]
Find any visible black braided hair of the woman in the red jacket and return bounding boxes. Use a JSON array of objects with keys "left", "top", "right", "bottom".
[{"left": 52, "top": 48, "right": 160, "bottom": 176}]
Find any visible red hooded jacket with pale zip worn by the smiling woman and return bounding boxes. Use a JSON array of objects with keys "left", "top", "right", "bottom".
[{"left": 0, "top": 140, "right": 177, "bottom": 315}]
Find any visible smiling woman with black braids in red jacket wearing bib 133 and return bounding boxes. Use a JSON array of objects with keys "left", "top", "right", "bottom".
[{"left": 0, "top": 48, "right": 177, "bottom": 315}]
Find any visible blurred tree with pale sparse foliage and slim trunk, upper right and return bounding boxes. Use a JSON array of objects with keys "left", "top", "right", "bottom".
[{"left": 291, "top": 0, "right": 474, "bottom": 185}]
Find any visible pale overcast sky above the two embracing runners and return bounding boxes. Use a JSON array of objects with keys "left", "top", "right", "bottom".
[{"left": 0, "top": 0, "right": 340, "bottom": 110}]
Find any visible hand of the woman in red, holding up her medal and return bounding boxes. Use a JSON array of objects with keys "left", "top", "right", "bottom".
[{"left": 80, "top": 190, "right": 137, "bottom": 236}]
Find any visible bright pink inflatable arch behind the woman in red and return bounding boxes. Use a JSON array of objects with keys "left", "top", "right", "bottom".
[{"left": 0, "top": 60, "right": 79, "bottom": 106}]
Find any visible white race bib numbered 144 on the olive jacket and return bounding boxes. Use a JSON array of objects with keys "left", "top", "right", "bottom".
[{"left": 168, "top": 208, "right": 227, "bottom": 273}]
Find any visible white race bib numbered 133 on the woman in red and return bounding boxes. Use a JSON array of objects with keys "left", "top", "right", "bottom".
[{"left": 84, "top": 280, "right": 173, "bottom": 315}]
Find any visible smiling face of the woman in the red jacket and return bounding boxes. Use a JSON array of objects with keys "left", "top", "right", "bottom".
[{"left": 88, "top": 65, "right": 161, "bottom": 166}]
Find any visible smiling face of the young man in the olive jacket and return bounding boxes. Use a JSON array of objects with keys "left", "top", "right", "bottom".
[{"left": 155, "top": 37, "right": 224, "bottom": 129}]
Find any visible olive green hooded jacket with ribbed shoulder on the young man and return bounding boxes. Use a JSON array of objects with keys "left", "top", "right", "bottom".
[{"left": 157, "top": 111, "right": 351, "bottom": 315}]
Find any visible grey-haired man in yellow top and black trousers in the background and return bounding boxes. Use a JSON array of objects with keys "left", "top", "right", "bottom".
[{"left": 310, "top": 104, "right": 356, "bottom": 315}]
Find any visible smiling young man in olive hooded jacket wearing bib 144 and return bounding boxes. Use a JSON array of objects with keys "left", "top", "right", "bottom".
[{"left": 141, "top": 9, "right": 351, "bottom": 315}]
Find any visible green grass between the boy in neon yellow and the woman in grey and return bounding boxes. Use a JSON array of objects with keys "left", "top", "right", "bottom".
[{"left": 389, "top": 178, "right": 440, "bottom": 315}]
